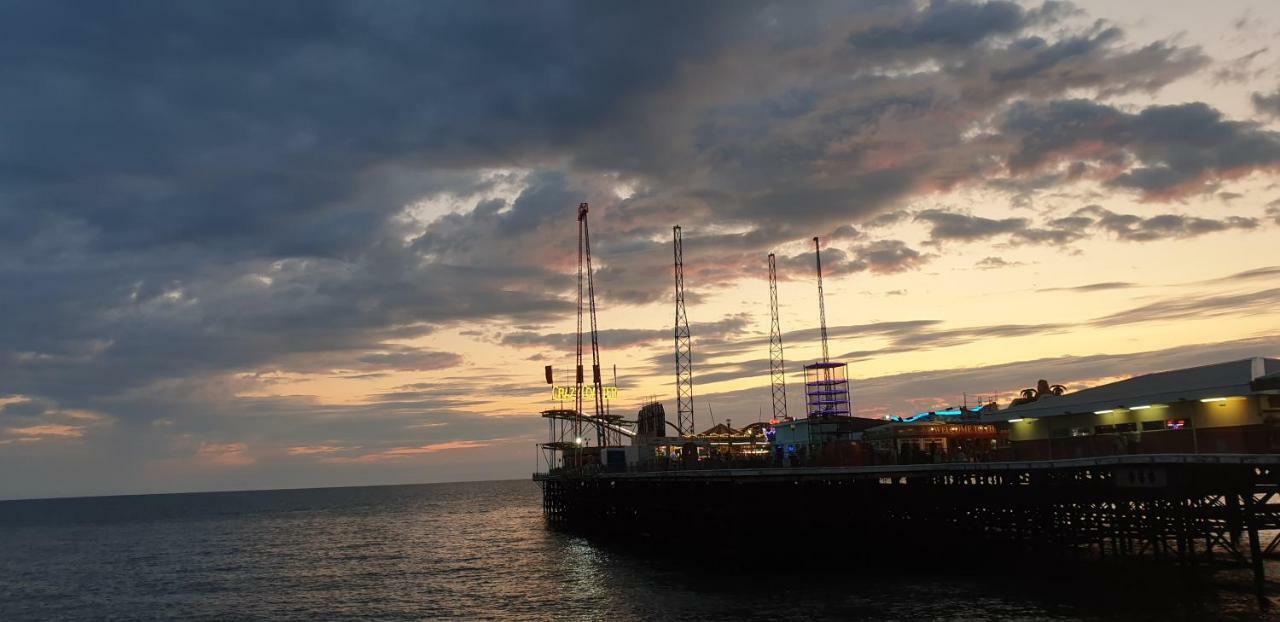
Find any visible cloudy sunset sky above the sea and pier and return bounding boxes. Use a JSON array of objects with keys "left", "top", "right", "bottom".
[{"left": 0, "top": 0, "right": 1280, "bottom": 498}]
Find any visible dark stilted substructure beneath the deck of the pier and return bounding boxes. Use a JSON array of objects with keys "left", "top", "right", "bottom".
[{"left": 534, "top": 454, "right": 1280, "bottom": 596}]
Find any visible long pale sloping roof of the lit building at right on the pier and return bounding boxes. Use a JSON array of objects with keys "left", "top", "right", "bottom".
[{"left": 982, "top": 358, "right": 1280, "bottom": 422}]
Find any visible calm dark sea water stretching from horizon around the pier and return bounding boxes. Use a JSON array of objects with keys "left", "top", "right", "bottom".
[{"left": 0, "top": 481, "right": 1280, "bottom": 621}]
